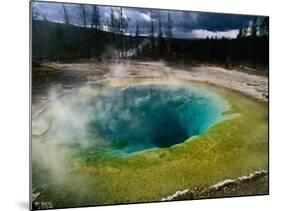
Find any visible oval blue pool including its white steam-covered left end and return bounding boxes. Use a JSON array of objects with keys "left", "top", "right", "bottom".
[{"left": 34, "top": 84, "right": 227, "bottom": 154}]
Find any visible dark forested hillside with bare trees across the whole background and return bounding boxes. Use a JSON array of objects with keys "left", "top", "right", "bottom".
[{"left": 32, "top": 4, "right": 269, "bottom": 68}]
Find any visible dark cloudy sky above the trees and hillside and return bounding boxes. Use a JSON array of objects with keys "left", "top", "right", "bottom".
[{"left": 32, "top": 2, "right": 262, "bottom": 38}]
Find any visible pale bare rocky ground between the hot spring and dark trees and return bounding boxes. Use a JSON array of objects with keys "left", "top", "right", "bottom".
[{"left": 32, "top": 61, "right": 268, "bottom": 115}]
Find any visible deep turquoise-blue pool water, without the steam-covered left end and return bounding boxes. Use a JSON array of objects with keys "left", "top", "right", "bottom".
[{"left": 87, "top": 85, "right": 225, "bottom": 153}]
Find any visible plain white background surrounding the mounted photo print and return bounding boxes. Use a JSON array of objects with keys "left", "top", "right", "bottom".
[{"left": 0, "top": 0, "right": 281, "bottom": 211}]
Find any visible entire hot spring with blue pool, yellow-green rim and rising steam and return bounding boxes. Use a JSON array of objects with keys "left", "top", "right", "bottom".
[{"left": 32, "top": 78, "right": 268, "bottom": 207}]
